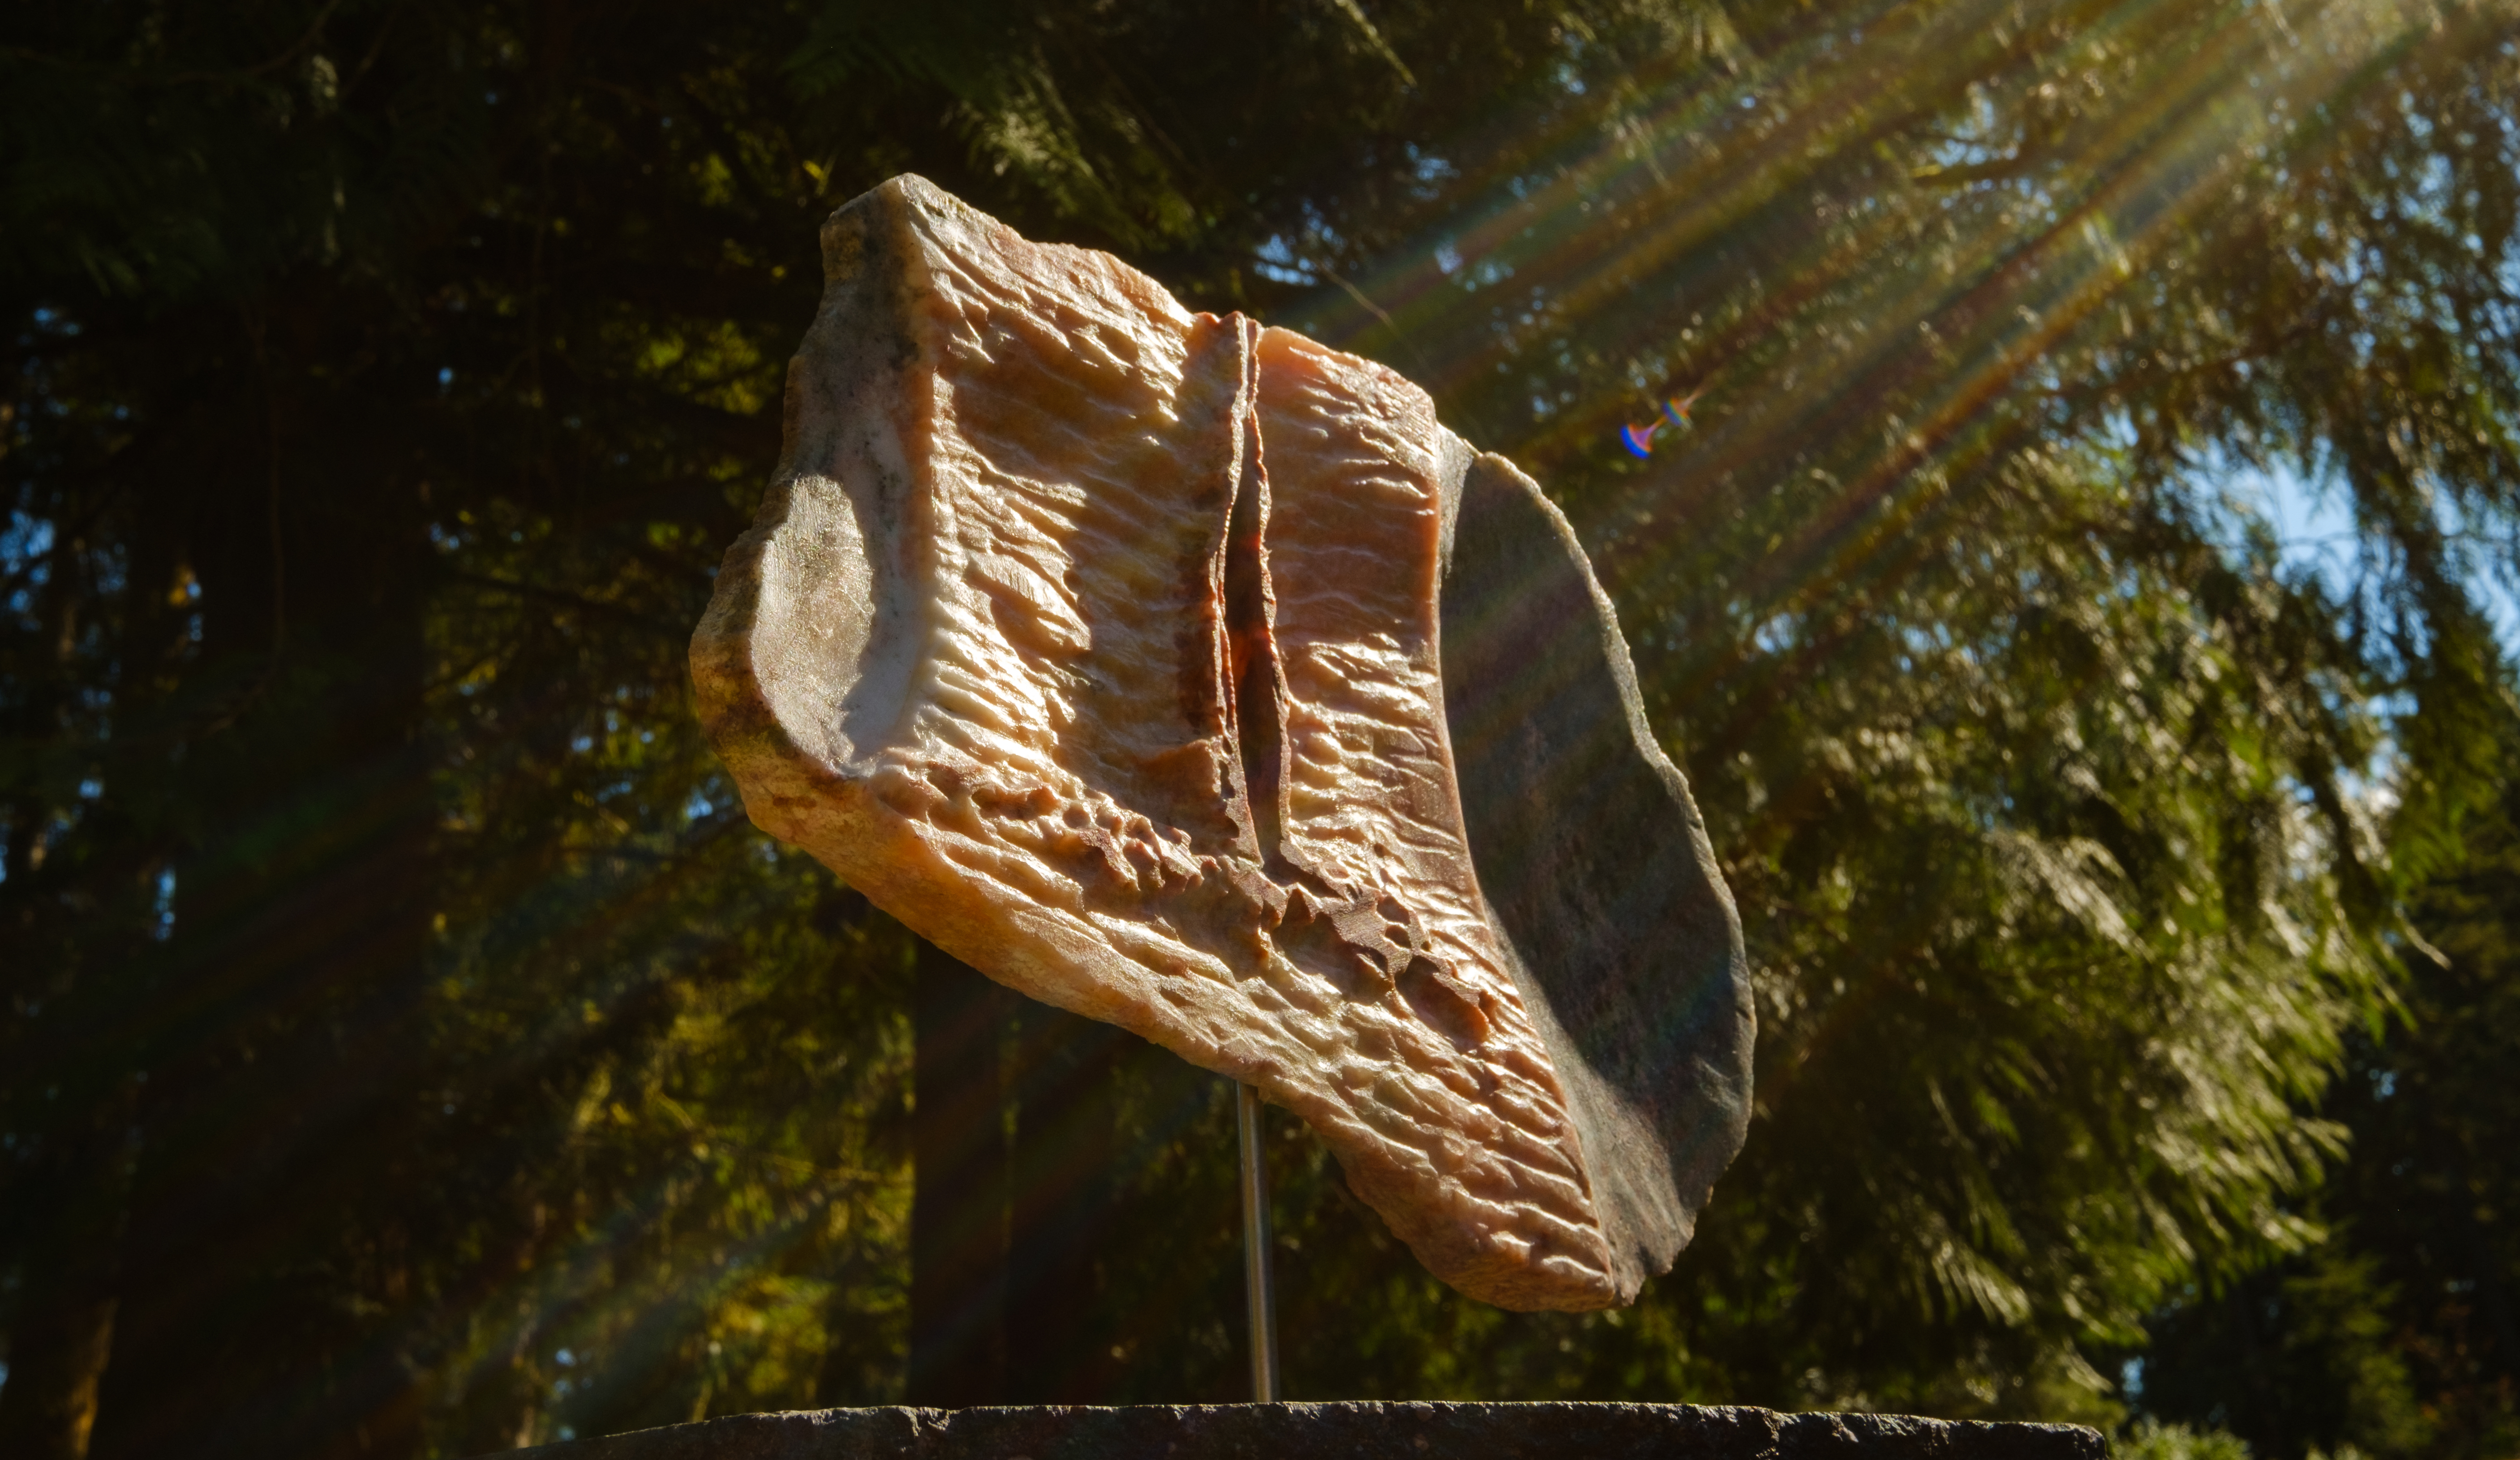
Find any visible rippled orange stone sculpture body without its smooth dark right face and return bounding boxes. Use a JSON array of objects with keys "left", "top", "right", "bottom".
[{"left": 693, "top": 179, "right": 1747, "bottom": 1309}]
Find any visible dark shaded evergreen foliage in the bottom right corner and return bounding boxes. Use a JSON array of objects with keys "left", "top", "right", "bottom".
[{"left": 2137, "top": 756, "right": 2520, "bottom": 1460}]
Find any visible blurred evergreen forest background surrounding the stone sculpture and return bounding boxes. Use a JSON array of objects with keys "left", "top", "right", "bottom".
[{"left": 0, "top": 0, "right": 2520, "bottom": 1460}]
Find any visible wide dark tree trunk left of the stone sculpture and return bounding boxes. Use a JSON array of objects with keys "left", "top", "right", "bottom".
[{"left": 77, "top": 295, "right": 436, "bottom": 1460}]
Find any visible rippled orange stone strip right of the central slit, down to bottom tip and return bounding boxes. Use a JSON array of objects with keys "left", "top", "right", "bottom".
[{"left": 1260, "top": 330, "right": 1602, "bottom": 1306}]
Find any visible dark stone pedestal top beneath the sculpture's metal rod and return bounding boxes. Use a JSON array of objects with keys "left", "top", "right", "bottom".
[{"left": 491, "top": 1404, "right": 2109, "bottom": 1460}]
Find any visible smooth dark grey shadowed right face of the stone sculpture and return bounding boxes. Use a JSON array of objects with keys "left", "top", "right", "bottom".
[{"left": 1442, "top": 457, "right": 1754, "bottom": 1294}]
